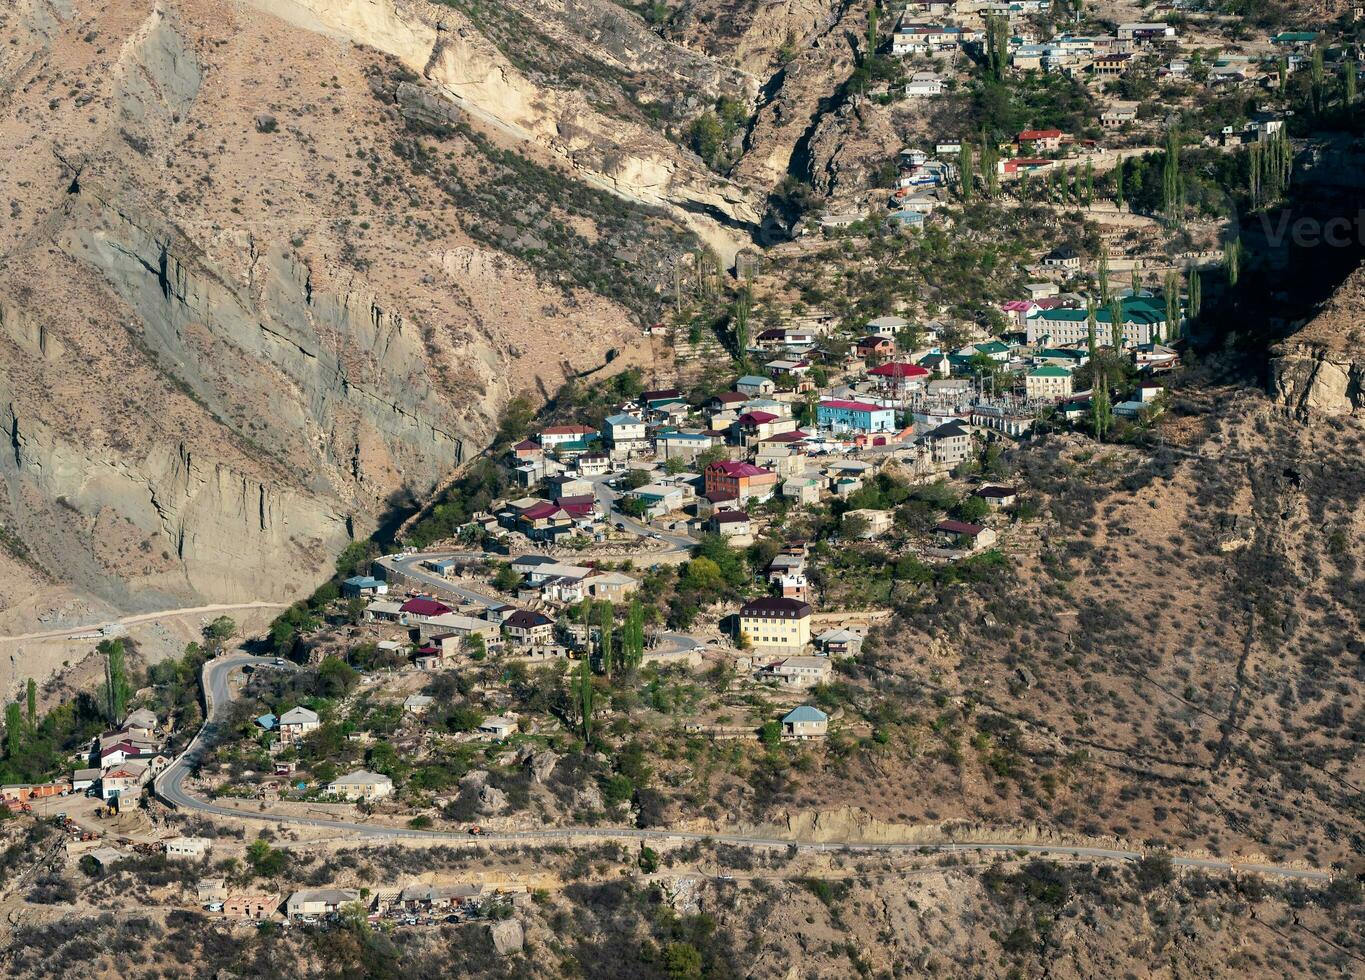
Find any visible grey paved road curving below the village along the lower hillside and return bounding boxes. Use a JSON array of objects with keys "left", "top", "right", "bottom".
[{"left": 154, "top": 654, "right": 1331, "bottom": 882}]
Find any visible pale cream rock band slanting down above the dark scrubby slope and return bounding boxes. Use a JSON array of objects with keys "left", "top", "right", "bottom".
[{"left": 251, "top": 0, "right": 764, "bottom": 258}]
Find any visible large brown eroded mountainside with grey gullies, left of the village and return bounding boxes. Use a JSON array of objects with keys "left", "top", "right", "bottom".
[{"left": 0, "top": 0, "right": 655, "bottom": 631}]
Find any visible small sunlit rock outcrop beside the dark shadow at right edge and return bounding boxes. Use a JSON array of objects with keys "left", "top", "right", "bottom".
[{"left": 1271, "top": 260, "right": 1365, "bottom": 415}]
